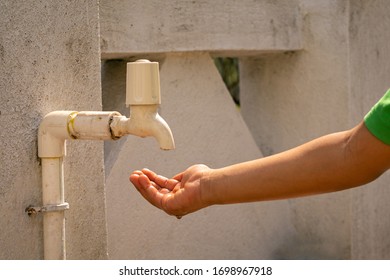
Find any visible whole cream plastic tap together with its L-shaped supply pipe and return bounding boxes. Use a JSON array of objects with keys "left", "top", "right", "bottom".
[{"left": 32, "top": 60, "right": 175, "bottom": 260}]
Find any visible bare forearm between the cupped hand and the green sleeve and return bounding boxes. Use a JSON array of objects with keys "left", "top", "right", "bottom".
[{"left": 205, "top": 124, "right": 390, "bottom": 204}]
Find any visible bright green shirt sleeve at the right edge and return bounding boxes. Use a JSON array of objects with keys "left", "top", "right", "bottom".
[{"left": 364, "top": 89, "right": 390, "bottom": 145}]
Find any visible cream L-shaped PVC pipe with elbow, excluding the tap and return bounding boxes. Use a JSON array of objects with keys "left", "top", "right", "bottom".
[{"left": 38, "top": 111, "right": 120, "bottom": 260}]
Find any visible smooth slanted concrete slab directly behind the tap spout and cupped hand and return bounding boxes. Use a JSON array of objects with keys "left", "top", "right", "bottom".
[{"left": 103, "top": 53, "right": 292, "bottom": 259}]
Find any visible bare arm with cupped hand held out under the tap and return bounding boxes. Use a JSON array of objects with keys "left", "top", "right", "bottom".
[{"left": 130, "top": 122, "right": 390, "bottom": 215}]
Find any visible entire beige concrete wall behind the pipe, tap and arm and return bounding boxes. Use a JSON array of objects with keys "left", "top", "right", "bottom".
[{"left": 0, "top": 0, "right": 390, "bottom": 259}]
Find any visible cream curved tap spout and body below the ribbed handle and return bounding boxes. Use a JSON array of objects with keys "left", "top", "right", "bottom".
[{"left": 110, "top": 105, "right": 175, "bottom": 150}]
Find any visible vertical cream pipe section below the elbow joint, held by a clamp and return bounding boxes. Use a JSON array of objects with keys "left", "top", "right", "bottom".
[{"left": 42, "top": 157, "right": 66, "bottom": 260}]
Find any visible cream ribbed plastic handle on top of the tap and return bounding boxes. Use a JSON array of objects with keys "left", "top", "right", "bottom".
[{"left": 126, "top": 59, "right": 161, "bottom": 107}]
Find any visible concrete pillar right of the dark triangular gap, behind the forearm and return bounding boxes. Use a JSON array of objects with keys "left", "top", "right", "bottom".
[{"left": 240, "top": 0, "right": 352, "bottom": 259}]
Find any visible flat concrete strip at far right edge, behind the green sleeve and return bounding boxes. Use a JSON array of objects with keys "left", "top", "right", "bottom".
[{"left": 349, "top": 0, "right": 390, "bottom": 259}]
